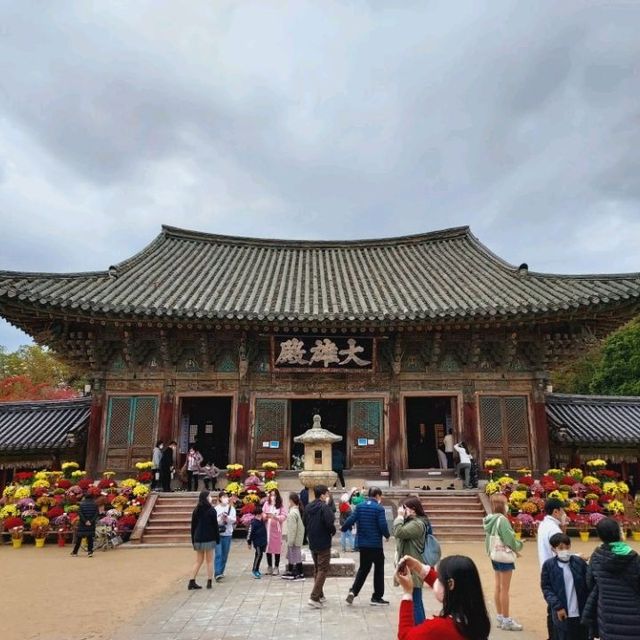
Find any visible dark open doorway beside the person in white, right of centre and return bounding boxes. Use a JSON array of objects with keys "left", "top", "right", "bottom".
[{"left": 405, "top": 396, "right": 455, "bottom": 469}]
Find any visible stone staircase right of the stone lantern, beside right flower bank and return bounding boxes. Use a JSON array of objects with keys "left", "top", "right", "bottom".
[{"left": 420, "top": 491, "right": 486, "bottom": 542}]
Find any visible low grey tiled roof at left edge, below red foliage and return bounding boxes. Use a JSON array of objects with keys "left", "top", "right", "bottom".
[{"left": 0, "top": 398, "right": 91, "bottom": 453}]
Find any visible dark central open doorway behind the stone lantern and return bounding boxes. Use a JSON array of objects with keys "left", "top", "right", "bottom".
[{"left": 289, "top": 399, "right": 349, "bottom": 467}]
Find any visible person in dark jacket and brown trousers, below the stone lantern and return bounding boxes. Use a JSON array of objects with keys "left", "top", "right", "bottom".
[{"left": 303, "top": 484, "right": 336, "bottom": 609}]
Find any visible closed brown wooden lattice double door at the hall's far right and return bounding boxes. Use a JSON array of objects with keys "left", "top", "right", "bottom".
[{"left": 480, "top": 396, "right": 531, "bottom": 469}]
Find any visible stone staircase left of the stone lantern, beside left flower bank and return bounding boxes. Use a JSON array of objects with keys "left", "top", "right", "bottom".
[{"left": 139, "top": 491, "right": 198, "bottom": 544}]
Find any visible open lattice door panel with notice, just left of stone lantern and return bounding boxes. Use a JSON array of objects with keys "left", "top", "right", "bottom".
[{"left": 253, "top": 398, "right": 289, "bottom": 469}]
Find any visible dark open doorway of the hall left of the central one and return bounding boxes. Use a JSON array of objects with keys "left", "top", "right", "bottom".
[{"left": 180, "top": 396, "right": 232, "bottom": 468}]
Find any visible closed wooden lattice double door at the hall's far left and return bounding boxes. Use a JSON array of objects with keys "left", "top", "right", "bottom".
[{"left": 104, "top": 396, "right": 158, "bottom": 471}]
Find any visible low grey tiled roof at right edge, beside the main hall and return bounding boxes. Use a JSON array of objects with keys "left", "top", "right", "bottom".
[{"left": 546, "top": 393, "right": 640, "bottom": 447}]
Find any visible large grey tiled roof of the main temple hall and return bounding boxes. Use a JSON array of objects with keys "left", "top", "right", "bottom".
[{"left": 0, "top": 227, "right": 640, "bottom": 323}]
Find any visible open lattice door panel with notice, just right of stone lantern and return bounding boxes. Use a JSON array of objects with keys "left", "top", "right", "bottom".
[{"left": 347, "top": 400, "right": 384, "bottom": 469}]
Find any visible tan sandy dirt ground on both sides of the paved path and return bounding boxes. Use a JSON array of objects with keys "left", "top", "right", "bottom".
[{"left": 5, "top": 540, "right": 640, "bottom": 640}]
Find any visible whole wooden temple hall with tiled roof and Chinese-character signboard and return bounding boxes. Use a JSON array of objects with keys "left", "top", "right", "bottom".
[{"left": 0, "top": 226, "right": 640, "bottom": 481}]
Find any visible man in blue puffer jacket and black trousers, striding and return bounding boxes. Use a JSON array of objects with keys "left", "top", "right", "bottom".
[{"left": 341, "top": 487, "right": 389, "bottom": 606}]
